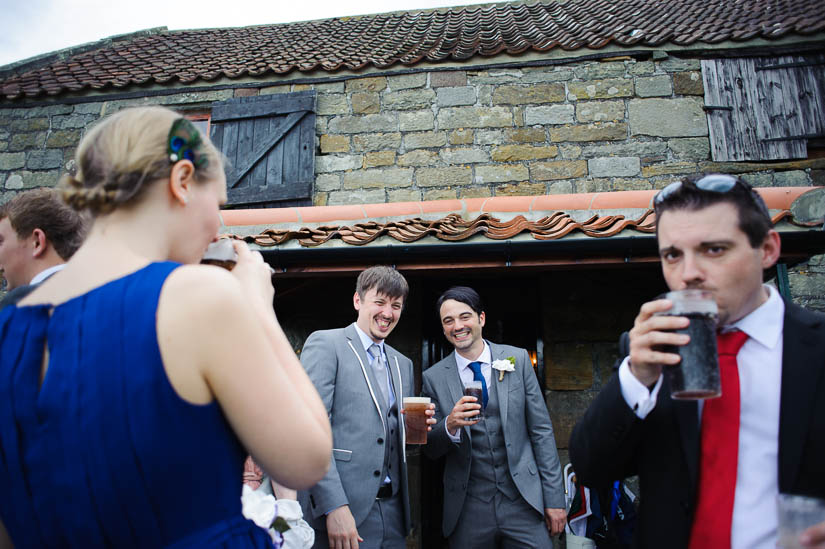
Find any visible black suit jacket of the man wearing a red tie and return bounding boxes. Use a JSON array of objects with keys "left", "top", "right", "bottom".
[{"left": 570, "top": 303, "right": 825, "bottom": 548}]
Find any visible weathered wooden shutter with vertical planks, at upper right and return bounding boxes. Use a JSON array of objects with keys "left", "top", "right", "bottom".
[{"left": 702, "top": 54, "right": 825, "bottom": 161}]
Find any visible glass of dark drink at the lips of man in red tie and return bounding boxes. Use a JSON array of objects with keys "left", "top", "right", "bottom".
[{"left": 658, "top": 290, "right": 722, "bottom": 400}]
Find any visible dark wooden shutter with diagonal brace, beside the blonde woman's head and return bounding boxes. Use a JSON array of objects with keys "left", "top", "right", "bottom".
[{"left": 210, "top": 90, "right": 315, "bottom": 208}]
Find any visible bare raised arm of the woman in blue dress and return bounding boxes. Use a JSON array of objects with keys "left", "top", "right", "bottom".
[{"left": 158, "top": 244, "right": 332, "bottom": 489}]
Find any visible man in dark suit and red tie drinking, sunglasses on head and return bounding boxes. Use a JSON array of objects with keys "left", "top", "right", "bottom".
[{"left": 570, "top": 174, "right": 825, "bottom": 549}]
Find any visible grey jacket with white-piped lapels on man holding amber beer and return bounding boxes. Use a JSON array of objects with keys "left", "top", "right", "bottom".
[{"left": 298, "top": 324, "right": 413, "bottom": 532}]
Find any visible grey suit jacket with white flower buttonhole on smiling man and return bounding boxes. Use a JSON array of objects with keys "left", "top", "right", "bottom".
[{"left": 423, "top": 341, "right": 565, "bottom": 536}]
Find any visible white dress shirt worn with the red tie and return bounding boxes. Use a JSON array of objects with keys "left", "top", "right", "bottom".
[{"left": 619, "top": 285, "right": 785, "bottom": 549}]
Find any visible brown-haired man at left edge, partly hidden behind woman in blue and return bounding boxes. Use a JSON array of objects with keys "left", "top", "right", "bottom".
[{"left": 0, "top": 189, "right": 86, "bottom": 308}]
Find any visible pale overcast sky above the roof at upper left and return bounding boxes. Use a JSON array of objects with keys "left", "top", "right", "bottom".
[{"left": 0, "top": 0, "right": 492, "bottom": 66}]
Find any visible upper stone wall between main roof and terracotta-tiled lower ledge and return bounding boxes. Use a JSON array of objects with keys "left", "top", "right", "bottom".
[{"left": 0, "top": 55, "right": 825, "bottom": 309}]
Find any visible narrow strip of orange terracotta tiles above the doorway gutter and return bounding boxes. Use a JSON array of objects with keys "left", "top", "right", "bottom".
[{"left": 223, "top": 187, "right": 822, "bottom": 248}]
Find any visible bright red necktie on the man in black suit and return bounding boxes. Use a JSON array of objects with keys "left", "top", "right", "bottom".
[{"left": 690, "top": 330, "right": 748, "bottom": 549}]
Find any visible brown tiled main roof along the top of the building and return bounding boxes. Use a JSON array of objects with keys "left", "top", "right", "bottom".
[{"left": 0, "top": 0, "right": 825, "bottom": 99}]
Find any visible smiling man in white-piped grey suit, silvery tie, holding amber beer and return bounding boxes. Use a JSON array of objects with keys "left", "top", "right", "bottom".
[{"left": 298, "top": 266, "right": 435, "bottom": 549}]
